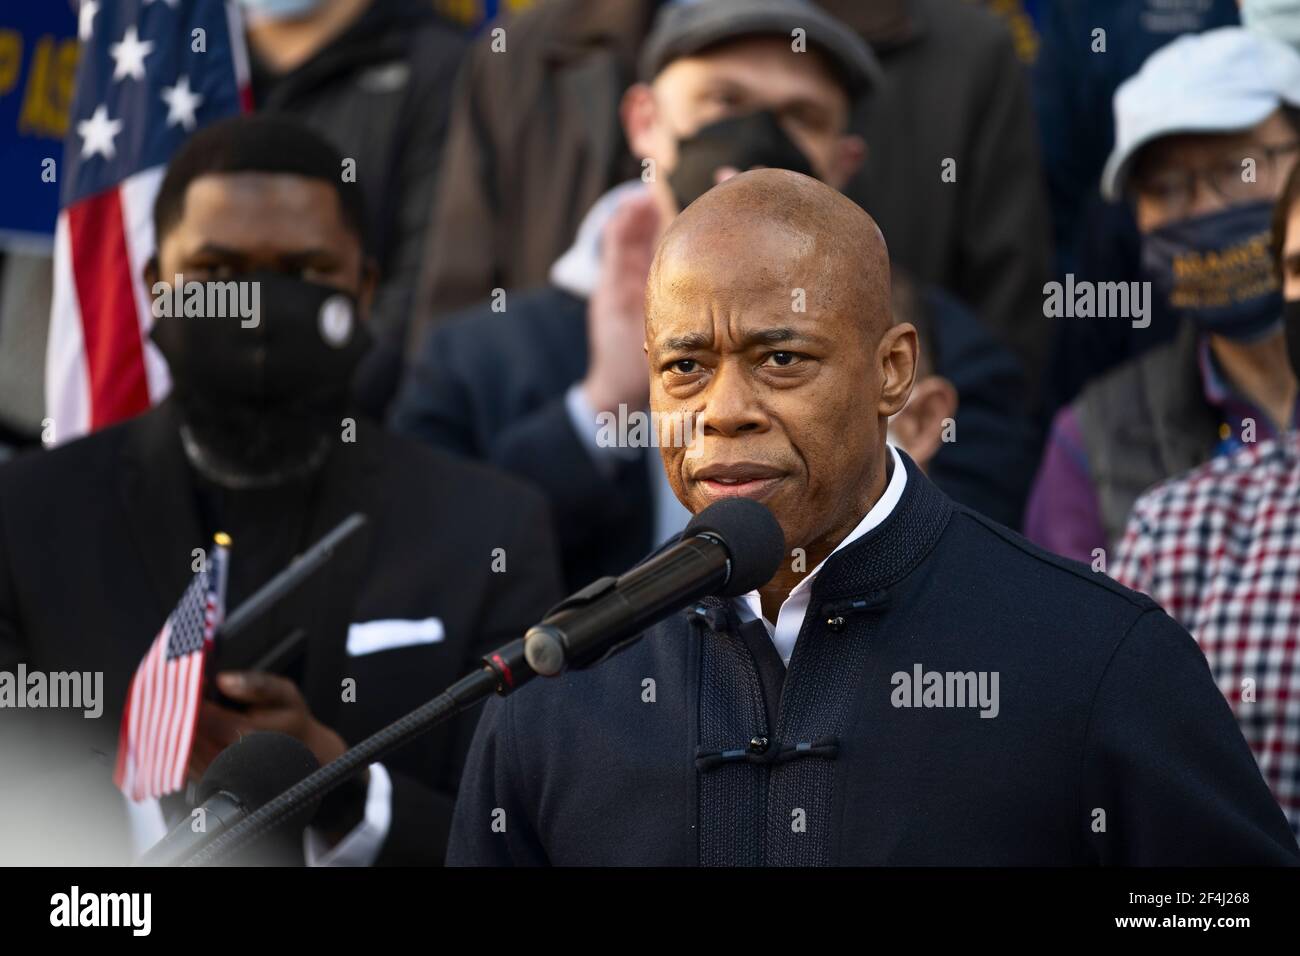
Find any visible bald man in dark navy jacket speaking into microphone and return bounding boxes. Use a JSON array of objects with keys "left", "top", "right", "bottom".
[{"left": 449, "top": 169, "right": 1297, "bottom": 866}]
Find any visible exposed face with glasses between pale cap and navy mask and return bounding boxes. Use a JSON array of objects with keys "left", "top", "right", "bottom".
[{"left": 1132, "top": 109, "right": 1297, "bottom": 233}]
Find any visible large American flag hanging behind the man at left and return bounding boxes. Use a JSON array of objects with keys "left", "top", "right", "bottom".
[{"left": 46, "top": 0, "right": 252, "bottom": 442}]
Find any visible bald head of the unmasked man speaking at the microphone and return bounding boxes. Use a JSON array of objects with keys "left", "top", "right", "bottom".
[{"left": 646, "top": 169, "right": 917, "bottom": 591}]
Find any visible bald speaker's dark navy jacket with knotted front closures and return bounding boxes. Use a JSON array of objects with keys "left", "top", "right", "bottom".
[{"left": 447, "top": 459, "right": 1297, "bottom": 866}]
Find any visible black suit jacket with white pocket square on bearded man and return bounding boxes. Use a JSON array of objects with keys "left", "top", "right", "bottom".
[{"left": 0, "top": 402, "right": 569, "bottom": 864}]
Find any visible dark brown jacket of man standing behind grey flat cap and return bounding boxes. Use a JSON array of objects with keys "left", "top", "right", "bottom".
[{"left": 415, "top": 0, "right": 1049, "bottom": 392}]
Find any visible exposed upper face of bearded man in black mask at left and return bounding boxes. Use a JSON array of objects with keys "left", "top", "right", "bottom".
[{"left": 148, "top": 173, "right": 372, "bottom": 297}]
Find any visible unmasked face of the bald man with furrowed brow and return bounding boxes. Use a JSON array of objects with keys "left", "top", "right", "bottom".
[{"left": 646, "top": 225, "right": 915, "bottom": 548}]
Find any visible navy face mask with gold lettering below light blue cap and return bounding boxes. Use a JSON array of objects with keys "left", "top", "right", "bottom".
[{"left": 1141, "top": 203, "right": 1282, "bottom": 342}]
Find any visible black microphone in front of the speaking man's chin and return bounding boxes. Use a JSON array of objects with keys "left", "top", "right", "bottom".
[{"left": 524, "top": 498, "right": 785, "bottom": 676}]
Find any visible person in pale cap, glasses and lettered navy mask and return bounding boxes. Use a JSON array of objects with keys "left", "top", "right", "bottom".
[{"left": 1024, "top": 27, "right": 1300, "bottom": 563}]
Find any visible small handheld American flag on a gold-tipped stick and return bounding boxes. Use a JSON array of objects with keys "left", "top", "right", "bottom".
[{"left": 113, "top": 535, "right": 230, "bottom": 801}]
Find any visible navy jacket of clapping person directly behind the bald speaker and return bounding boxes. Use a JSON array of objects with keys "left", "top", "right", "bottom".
[{"left": 391, "top": 280, "right": 1037, "bottom": 588}]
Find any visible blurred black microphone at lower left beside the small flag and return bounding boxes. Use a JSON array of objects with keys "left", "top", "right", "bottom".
[{"left": 138, "top": 731, "right": 320, "bottom": 866}]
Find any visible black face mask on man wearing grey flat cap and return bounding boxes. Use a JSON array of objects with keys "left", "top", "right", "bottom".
[{"left": 668, "top": 109, "right": 815, "bottom": 211}]
